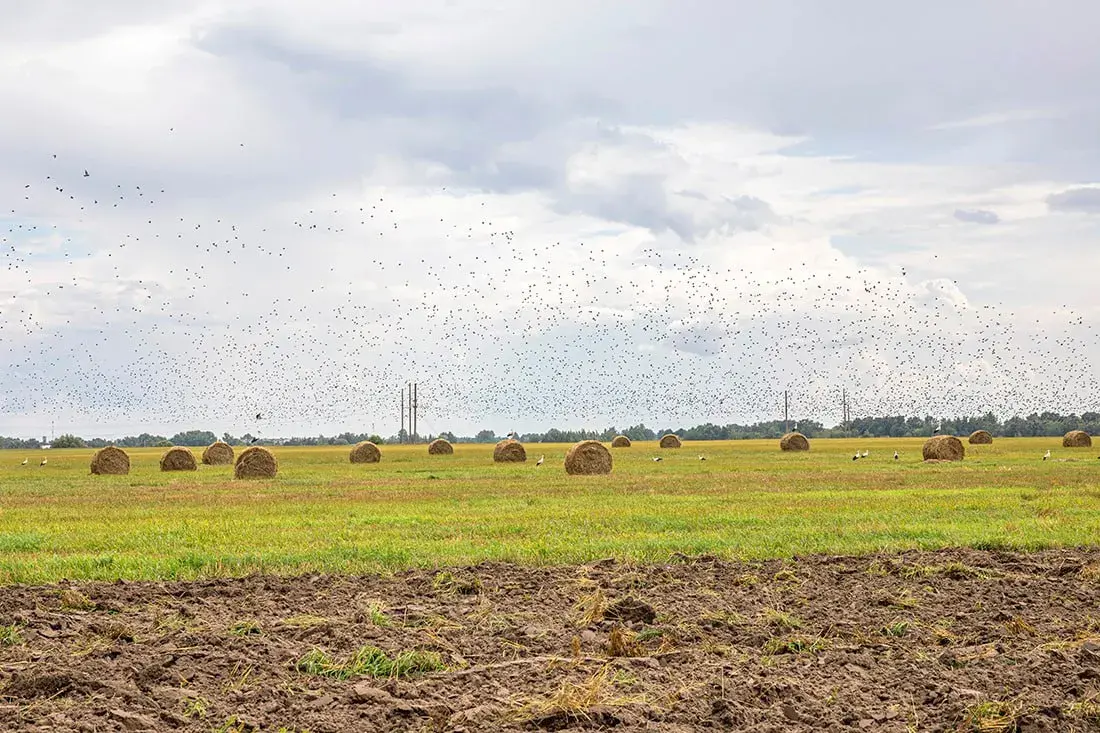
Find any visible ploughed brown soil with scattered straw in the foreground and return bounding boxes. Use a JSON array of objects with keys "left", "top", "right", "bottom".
[{"left": 0, "top": 549, "right": 1100, "bottom": 733}]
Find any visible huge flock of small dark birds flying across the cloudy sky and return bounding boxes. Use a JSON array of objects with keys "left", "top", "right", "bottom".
[{"left": 0, "top": 132, "right": 1100, "bottom": 435}]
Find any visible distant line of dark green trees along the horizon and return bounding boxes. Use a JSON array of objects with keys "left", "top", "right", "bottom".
[{"left": 0, "top": 412, "right": 1100, "bottom": 449}]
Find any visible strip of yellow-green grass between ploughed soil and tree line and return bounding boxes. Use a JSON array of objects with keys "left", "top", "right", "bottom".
[{"left": 0, "top": 438, "right": 1100, "bottom": 583}]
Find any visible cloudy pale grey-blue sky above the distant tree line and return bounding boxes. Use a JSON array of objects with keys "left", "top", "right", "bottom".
[{"left": 0, "top": 0, "right": 1100, "bottom": 437}]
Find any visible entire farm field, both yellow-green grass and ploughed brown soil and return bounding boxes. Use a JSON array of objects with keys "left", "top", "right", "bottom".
[{"left": 0, "top": 438, "right": 1100, "bottom": 733}]
